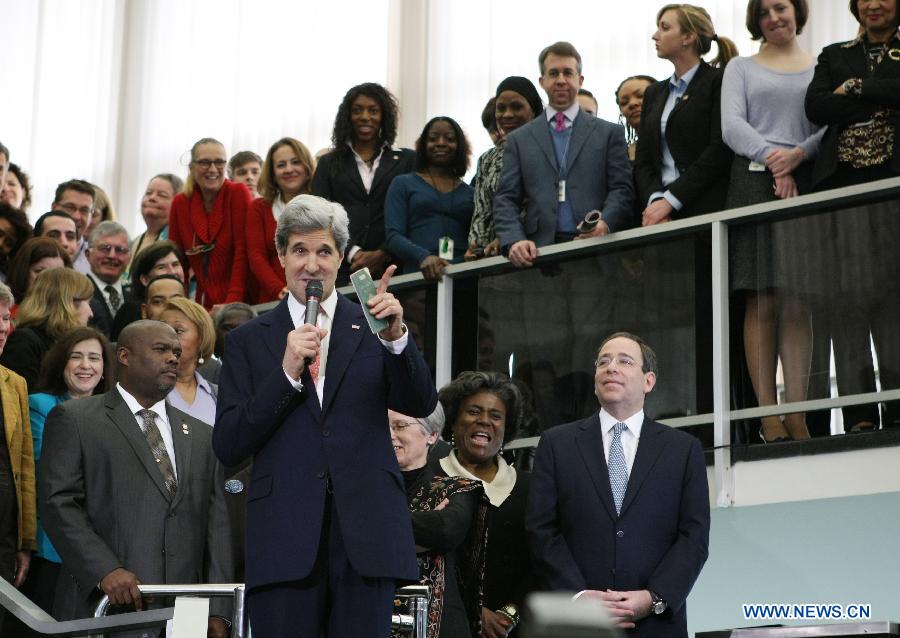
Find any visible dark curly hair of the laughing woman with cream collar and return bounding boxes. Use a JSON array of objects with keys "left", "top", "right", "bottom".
[{"left": 438, "top": 370, "right": 524, "bottom": 448}]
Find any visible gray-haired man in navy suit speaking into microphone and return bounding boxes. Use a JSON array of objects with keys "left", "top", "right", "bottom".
[{"left": 213, "top": 195, "right": 437, "bottom": 638}]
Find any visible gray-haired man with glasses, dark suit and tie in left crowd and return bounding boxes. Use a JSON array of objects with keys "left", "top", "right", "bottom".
[{"left": 86, "top": 221, "right": 133, "bottom": 337}]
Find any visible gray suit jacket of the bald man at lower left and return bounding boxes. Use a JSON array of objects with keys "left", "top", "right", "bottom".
[{"left": 38, "top": 389, "right": 234, "bottom": 619}]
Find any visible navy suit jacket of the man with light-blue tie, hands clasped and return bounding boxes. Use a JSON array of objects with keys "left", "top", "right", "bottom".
[{"left": 525, "top": 414, "right": 709, "bottom": 638}]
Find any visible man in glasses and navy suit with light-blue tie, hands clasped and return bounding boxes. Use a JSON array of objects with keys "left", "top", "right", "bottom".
[{"left": 525, "top": 333, "right": 709, "bottom": 638}]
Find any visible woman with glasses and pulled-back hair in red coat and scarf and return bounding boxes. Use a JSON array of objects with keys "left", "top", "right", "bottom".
[{"left": 169, "top": 137, "right": 251, "bottom": 312}]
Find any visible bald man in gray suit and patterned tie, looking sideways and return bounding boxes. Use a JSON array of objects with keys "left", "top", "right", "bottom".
[{"left": 38, "top": 320, "right": 233, "bottom": 636}]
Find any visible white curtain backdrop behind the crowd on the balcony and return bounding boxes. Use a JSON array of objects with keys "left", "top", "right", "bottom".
[{"left": 0, "top": 0, "right": 856, "bottom": 233}]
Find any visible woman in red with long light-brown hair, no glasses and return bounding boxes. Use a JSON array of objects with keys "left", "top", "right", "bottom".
[{"left": 247, "top": 137, "right": 315, "bottom": 303}]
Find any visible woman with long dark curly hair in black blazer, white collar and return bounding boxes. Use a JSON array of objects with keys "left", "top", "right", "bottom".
[{"left": 312, "top": 82, "right": 416, "bottom": 286}]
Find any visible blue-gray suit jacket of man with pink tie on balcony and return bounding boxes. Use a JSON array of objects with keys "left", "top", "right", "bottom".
[{"left": 494, "top": 111, "right": 635, "bottom": 249}]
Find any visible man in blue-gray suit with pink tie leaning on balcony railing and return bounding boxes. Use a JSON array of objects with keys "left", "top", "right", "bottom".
[{"left": 494, "top": 42, "right": 634, "bottom": 266}]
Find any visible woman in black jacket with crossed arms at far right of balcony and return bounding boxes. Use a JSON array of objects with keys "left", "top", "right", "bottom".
[{"left": 806, "top": 0, "right": 900, "bottom": 432}]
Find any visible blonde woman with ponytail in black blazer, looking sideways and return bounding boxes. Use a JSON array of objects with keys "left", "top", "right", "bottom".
[{"left": 634, "top": 4, "right": 737, "bottom": 226}]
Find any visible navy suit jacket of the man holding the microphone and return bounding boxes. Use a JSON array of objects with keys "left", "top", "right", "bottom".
[{"left": 213, "top": 295, "right": 437, "bottom": 587}]
